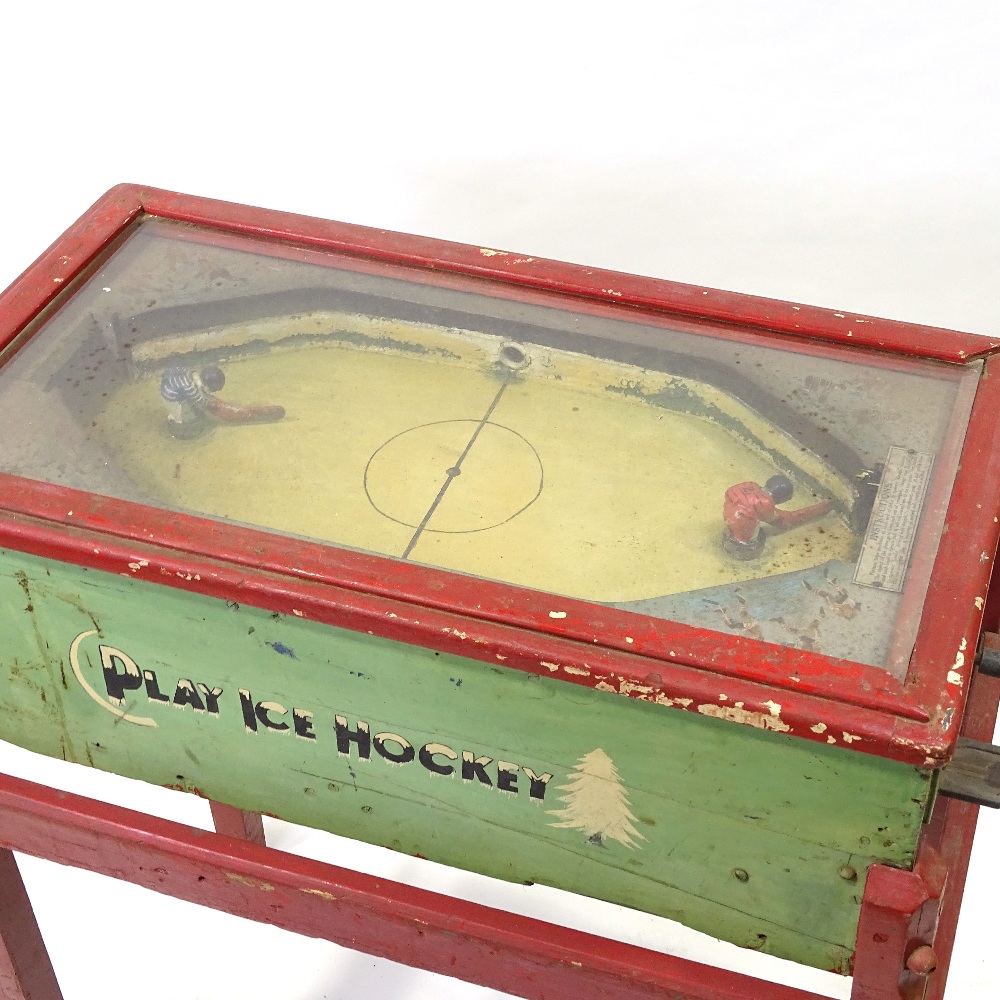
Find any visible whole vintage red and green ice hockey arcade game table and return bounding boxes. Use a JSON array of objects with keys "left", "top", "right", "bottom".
[{"left": 0, "top": 186, "right": 1000, "bottom": 1000}]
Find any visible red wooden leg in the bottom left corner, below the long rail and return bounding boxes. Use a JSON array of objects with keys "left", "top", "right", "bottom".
[{"left": 0, "top": 849, "right": 62, "bottom": 1000}]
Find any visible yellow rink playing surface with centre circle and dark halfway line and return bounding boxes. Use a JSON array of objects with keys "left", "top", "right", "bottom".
[{"left": 98, "top": 317, "right": 855, "bottom": 602}]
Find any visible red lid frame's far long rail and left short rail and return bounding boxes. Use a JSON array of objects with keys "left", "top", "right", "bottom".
[{"left": 0, "top": 184, "right": 1000, "bottom": 363}]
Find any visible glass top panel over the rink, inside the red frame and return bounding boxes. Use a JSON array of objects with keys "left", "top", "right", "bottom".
[{"left": 0, "top": 219, "right": 980, "bottom": 677}]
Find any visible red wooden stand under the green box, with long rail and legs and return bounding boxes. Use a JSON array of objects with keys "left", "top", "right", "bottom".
[{"left": 0, "top": 660, "right": 1000, "bottom": 1000}]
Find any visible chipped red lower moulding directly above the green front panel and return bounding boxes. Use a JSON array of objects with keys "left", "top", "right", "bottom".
[{"left": 0, "top": 511, "right": 928, "bottom": 766}]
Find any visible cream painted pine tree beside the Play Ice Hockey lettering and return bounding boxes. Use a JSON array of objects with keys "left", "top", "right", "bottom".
[{"left": 549, "top": 747, "right": 646, "bottom": 847}]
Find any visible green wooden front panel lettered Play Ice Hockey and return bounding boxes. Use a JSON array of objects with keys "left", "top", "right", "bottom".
[{"left": 0, "top": 552, "right": 929, "bottom": 971}]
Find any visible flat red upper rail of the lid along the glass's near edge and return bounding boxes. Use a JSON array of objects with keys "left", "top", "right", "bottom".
[{"left": 0, "top": 473, "right": 929, "bottom": 721}]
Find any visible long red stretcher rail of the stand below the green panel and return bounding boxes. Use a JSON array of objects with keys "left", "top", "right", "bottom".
[{"left": 0, "top": 776, "right": 821, "bottom": 1000}]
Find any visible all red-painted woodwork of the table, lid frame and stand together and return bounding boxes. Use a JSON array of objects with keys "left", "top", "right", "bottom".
[{"left": 0, "top": 186, "right": 1000, "bottom": 1000}]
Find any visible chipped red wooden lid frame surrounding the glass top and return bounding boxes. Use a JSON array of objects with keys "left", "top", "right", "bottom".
[{"left": 0, "top": 185, "right": 1000, "bottom": 766}]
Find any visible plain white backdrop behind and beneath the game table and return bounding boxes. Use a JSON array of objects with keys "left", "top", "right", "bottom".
[{"left": 0, "top": 0, "right": 1000, "bottom": 1000}]
